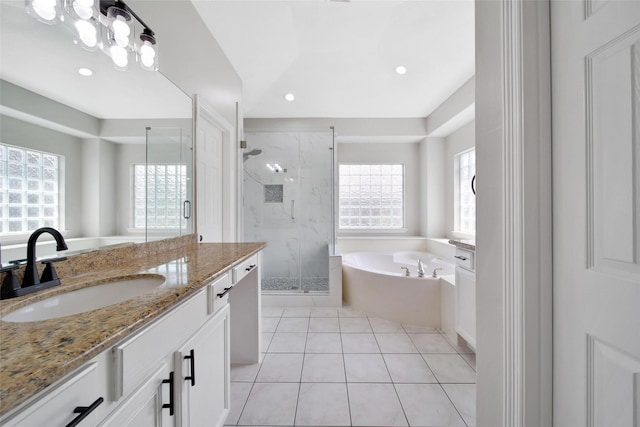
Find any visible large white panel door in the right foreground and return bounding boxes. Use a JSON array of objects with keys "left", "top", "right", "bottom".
[{"left": 551, "top": 0, "right": 640, "bottom": 427}]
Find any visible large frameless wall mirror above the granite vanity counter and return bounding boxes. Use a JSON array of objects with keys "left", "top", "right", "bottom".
[{"left": 0, "top": 0, "right": 193, "bottom": 262}]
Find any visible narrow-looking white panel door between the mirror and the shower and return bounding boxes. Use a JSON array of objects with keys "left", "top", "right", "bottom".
[{"left": 196, "top": 108, "right": 224, "bottom": 242}]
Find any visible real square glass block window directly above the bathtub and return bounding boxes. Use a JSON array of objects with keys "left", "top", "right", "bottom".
[{"left": 339, "top": 163, "right": 404, "bottom": 230}]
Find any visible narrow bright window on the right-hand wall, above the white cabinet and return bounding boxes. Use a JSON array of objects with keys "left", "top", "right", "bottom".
[{"left": 456, "top": 149, "right": 476, "bottom": 234}]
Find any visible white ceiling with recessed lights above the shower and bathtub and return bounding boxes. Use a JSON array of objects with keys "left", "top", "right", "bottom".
[{"left": 192, "top": 0, "right": 475, "bottom": 118}]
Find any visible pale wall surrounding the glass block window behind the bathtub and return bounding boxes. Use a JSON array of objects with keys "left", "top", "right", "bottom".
[{"left": 337, "top": 142, "right": 421, "bottom": 236}]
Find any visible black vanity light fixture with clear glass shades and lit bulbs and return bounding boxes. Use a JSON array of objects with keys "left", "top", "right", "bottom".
[{"left": 26, "top": 0, "right": 158, "bottom": 71}]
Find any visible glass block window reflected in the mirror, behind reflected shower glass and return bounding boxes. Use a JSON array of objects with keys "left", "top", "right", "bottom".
[{"left": 133, "top": 164, "right": 187, "bottom": 229}]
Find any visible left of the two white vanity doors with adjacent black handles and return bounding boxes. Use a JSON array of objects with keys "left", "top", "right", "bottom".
[{"left": 100, "top": 363, "right": 175, "bottom": 427}]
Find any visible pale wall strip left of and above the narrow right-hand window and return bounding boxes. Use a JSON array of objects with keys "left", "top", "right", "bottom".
[{"left": 444, "top": 121, "right": 476, "bottom": 238}]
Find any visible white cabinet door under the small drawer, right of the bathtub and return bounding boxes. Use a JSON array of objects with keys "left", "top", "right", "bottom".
[{"left": 456, "top": 267, "right": 476, "bottom": 349}]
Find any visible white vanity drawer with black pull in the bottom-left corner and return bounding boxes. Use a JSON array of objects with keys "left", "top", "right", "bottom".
[{"left": 2, "top": 362, "right": 105, "bottom": 427}]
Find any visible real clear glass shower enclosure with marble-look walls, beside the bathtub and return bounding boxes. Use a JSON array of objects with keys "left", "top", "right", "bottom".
[{"left": 243, "top": 130, "right": 334, "bottom": 293}]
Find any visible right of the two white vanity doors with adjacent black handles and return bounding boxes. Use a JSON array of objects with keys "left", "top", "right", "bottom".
[{"left": 174, "top": 304, "right": 230, "bottom": 427}]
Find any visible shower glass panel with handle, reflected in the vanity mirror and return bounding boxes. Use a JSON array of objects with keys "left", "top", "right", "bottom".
[{"left": 145, "top": 128, "right": 193, "bottom": 241}]
